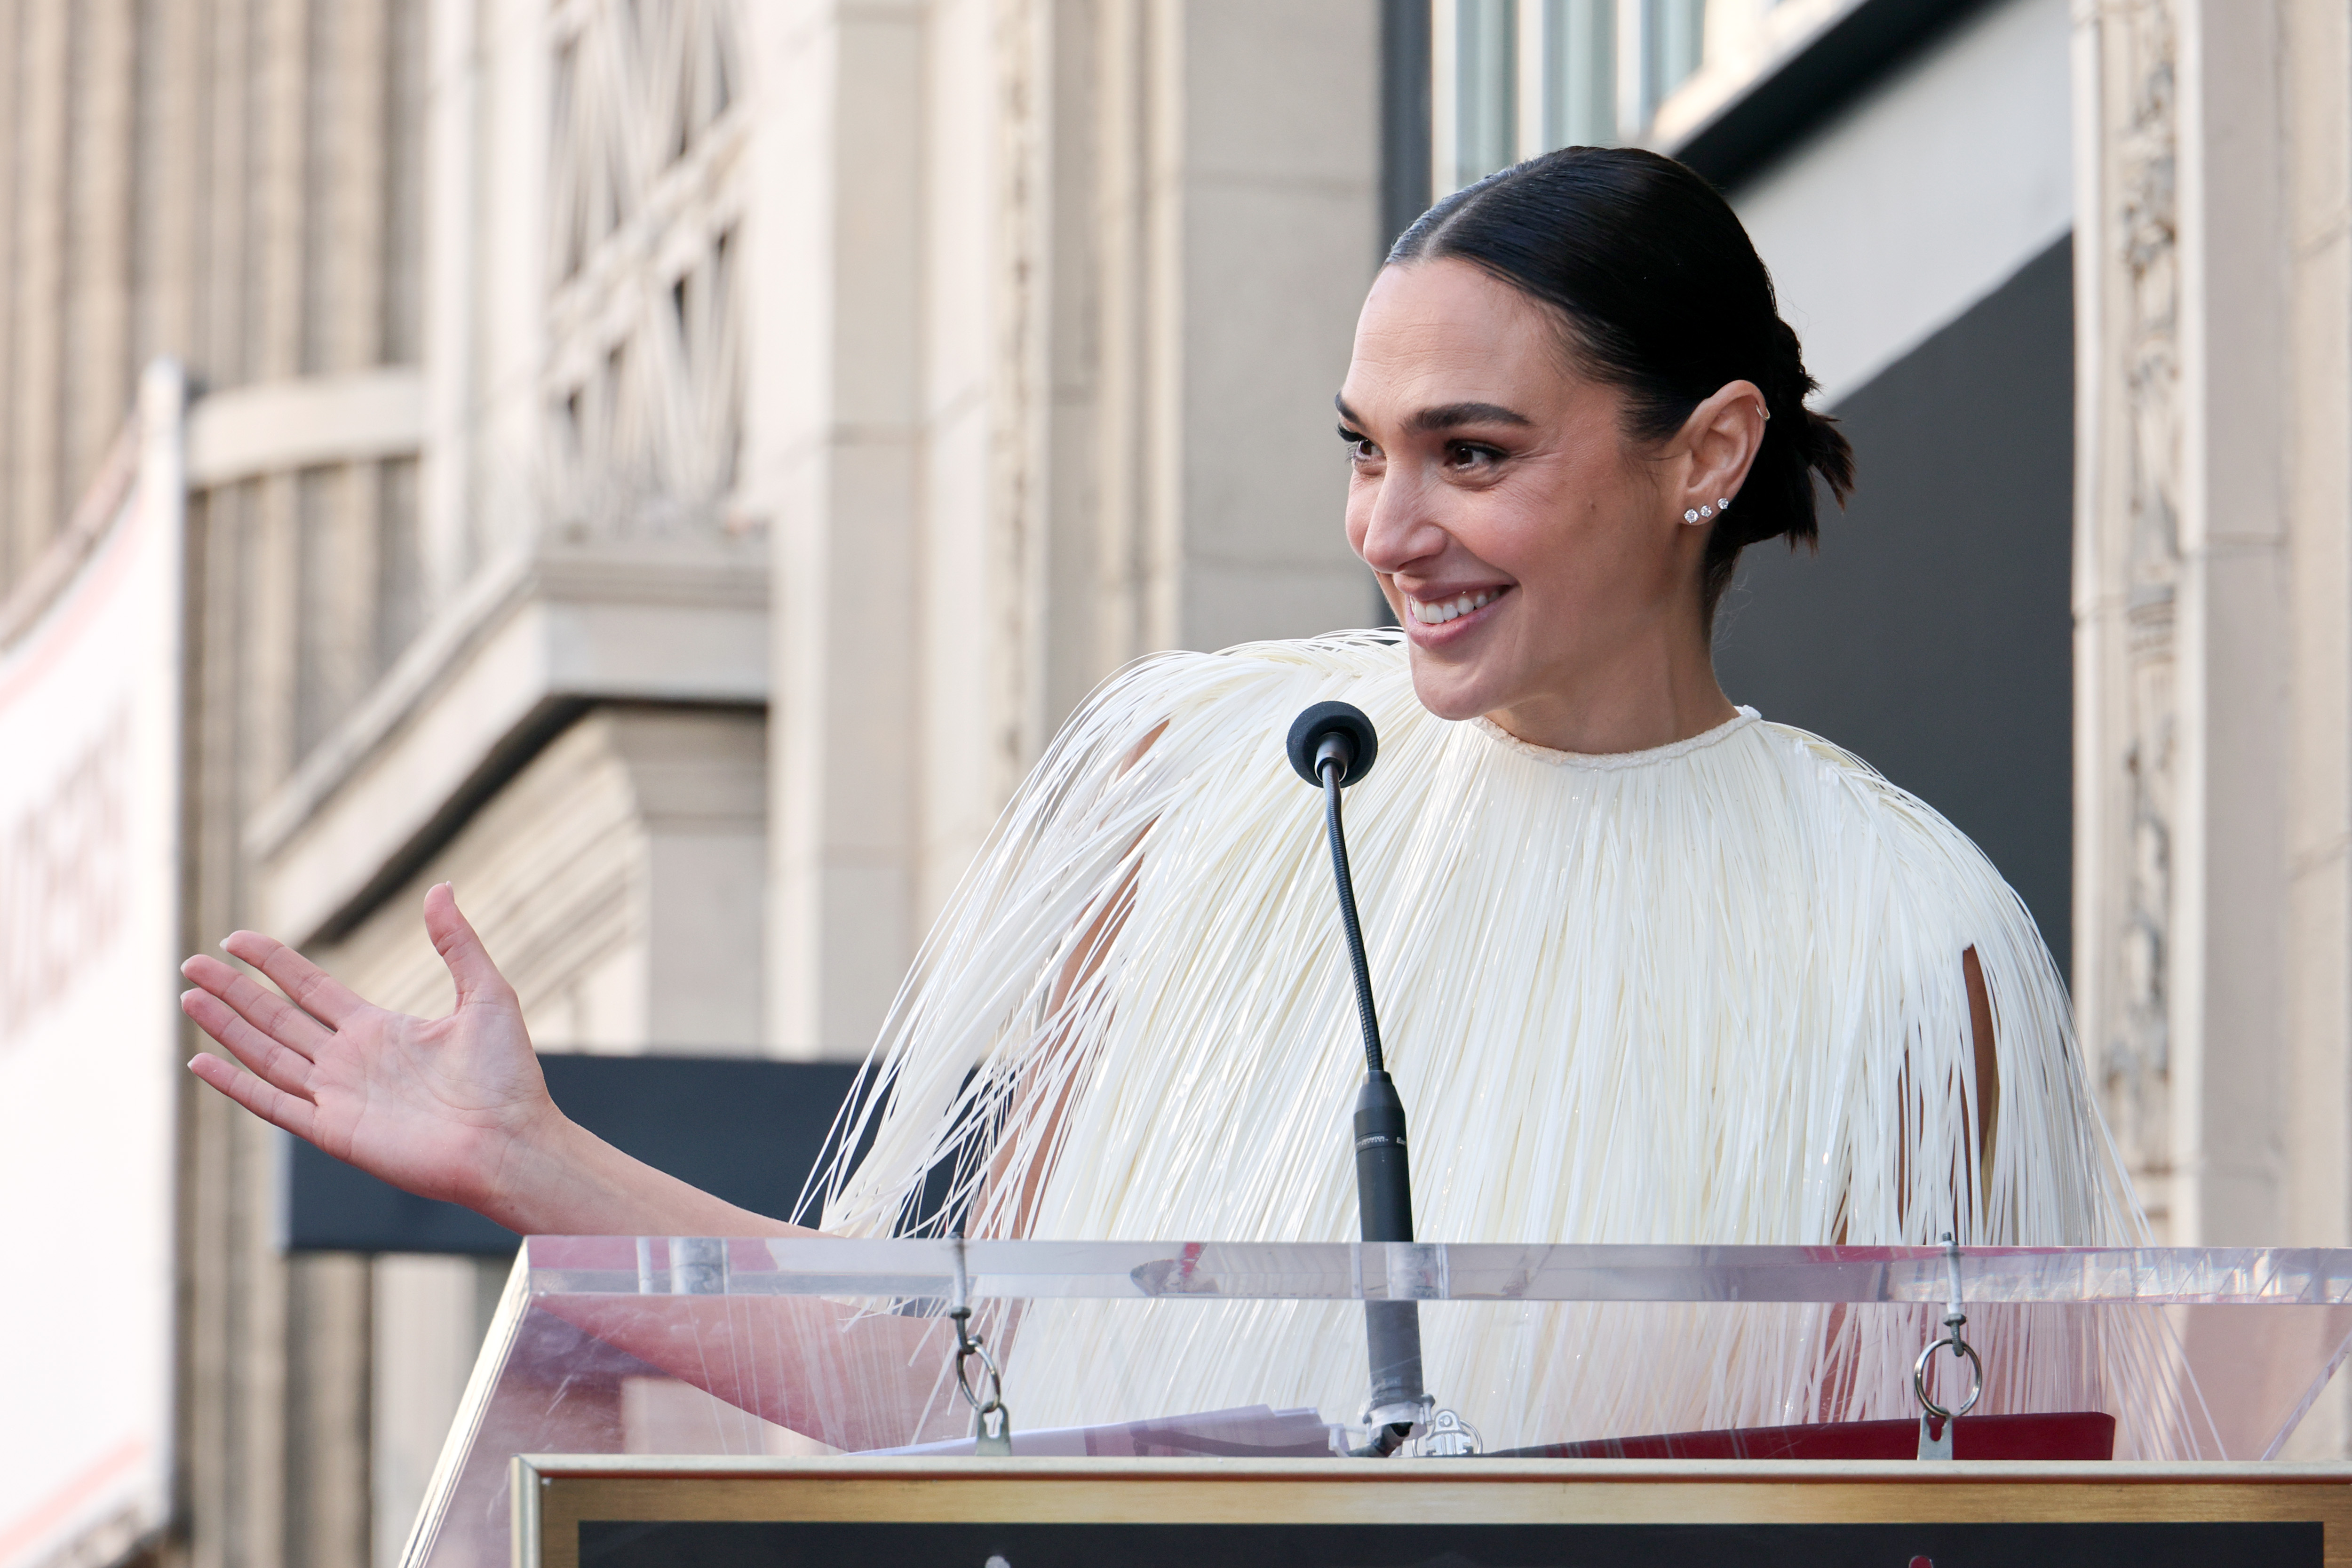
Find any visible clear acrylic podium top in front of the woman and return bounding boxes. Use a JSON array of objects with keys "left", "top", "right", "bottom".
[{"left": 402, "top": 1236, "right": 2352, "bottom": 1568}]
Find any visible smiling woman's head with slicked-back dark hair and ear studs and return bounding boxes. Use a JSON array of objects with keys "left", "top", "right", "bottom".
[{"left": 1338, "top": 148, "right": 1853, "bottom": 752}]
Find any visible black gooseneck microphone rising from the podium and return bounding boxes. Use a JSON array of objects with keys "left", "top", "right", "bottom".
[{"left": 1287, "top": 703, "right": 1430, "bottom": 1457}]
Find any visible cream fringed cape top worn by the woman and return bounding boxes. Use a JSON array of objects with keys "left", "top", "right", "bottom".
[{"left": 823, "top": 632, "right": 2178, "bottom": 1443}]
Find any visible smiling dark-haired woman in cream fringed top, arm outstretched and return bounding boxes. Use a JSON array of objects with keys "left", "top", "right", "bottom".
[{"left": 174, "top": 148, "right": 2157, "bottom": 1446}]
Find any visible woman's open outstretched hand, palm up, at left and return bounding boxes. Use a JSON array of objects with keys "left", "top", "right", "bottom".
[{"left": 179, "top": 882, "right": 567, "bottom": 1220}]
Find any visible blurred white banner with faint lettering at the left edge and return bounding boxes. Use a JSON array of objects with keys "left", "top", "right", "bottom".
[{"left": 0, "top": 365, "right": 183, "bottom": 1568}]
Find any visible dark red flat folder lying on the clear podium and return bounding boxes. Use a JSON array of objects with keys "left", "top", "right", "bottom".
[{"left": 1494, "top": 1410, "right": 2114, "bottom": 1460}]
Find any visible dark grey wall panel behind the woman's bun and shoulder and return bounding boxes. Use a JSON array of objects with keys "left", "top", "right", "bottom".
[{"left": 1715, "top": 240, "right": 2074, "bottom": 971}]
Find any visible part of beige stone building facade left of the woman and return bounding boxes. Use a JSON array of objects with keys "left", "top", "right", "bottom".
[{"left": 0, "top": 0, "right": 1383, "bottom": 1566}]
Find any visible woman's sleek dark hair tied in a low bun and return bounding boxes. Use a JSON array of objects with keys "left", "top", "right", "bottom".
[{"left": 1388, "top": 148, "right": 1853, "bottom": 623}]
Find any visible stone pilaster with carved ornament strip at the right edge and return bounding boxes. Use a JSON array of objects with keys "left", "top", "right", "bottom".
[{"left": 2074, "top": 0, "right": 2352, "bottom": 1450}]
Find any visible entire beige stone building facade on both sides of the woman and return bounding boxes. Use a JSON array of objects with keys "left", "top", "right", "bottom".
[{"left": 0, "top": 0, "right": 2352, "bottom": 1568}]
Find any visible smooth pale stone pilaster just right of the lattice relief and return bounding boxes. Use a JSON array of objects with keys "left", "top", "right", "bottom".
[{"left": 743, "top": 0, "right": 927, "bottom": 1058}]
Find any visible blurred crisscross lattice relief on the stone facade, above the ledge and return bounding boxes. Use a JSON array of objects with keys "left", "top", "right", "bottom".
[{"left": 541, "top": 0, "right": 746, "bottom": 541}]
